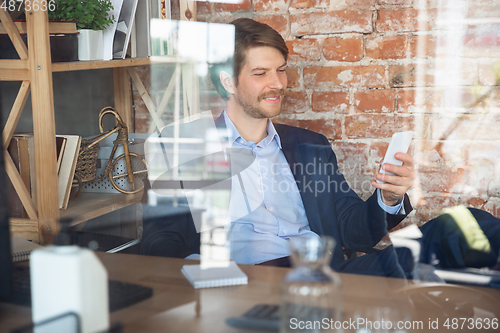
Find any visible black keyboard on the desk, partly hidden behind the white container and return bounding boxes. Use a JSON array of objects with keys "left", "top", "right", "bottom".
[{"left": 12, "top": 265, "right": 153, "bottom": 312}]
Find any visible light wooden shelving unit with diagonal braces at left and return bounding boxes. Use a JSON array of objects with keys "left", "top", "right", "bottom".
[{"left": 0, "top": 10, "right": 151, "bottom": 244}]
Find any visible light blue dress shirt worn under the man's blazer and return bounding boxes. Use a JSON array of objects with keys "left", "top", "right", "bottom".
[{"left": 223, "top": 111, "right": 402, "bottom": 264}]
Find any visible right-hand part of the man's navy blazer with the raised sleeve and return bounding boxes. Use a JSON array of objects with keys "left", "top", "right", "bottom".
[{"left": 275, "top": 124, "right": 412, "bottom": 263}]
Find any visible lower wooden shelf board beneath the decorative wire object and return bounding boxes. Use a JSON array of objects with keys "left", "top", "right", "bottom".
[{"left": 61, "top": 191, "right": 142, "bottom": 226}]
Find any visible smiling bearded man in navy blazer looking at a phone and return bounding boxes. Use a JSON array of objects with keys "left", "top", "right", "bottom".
[{"left": 139, "top": 18, "right": 416, "bottom": 277}]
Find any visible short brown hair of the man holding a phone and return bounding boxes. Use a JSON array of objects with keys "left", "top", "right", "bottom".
[{"left": 210, "top": 18, "right": 288, "bottom": 100}]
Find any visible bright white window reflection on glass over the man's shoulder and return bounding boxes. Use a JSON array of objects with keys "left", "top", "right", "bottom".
[{"left": 145, "top": 20, "right": 237, "bottom": 260}]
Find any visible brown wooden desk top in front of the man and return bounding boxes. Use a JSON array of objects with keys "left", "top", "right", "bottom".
[{"left": 0, "top": 253, "right": 500, "bottom": 333}]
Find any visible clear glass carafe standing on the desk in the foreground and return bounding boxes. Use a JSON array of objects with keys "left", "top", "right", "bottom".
[{"left": 280, "top": 236, "right": 342, "bottom": 333}]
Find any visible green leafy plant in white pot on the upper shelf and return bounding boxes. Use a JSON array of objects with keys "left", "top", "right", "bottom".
[{"left": 49, "top": 0, "right": 115, "bottom": 60}]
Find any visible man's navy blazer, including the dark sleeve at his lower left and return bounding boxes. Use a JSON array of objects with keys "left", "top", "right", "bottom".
[{"left": 141, "top": 118, "right": 412, "bottom": 275}]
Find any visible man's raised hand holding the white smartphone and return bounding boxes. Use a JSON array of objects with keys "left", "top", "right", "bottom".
[{"left": 372, "top": 153, "right": 417, "bottom": 206}]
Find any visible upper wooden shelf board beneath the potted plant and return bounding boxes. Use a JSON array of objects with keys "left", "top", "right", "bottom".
[{"left": 52, "top": 56, "right": 189, "bottom": 72}]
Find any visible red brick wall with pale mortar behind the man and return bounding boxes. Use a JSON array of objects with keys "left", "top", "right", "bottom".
[{"left": 133, "top": 0, "right": 500, "bottom": 222}]
